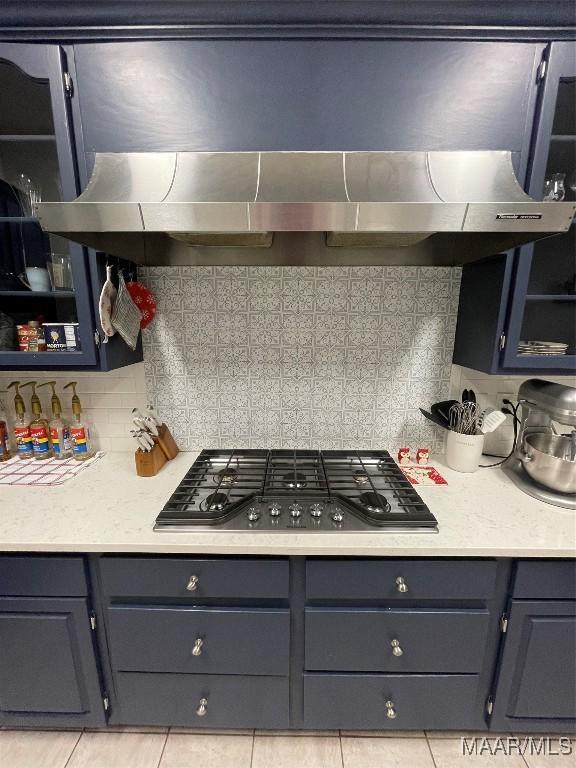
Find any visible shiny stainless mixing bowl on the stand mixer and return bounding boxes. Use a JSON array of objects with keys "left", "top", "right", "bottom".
[{"left": 522, "top": 432, "right": 576, "bottom": 493}]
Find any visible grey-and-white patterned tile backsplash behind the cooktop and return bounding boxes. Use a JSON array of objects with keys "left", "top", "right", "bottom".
[{"left": 140, "top": 266, "right": 460, "bottom": 450}]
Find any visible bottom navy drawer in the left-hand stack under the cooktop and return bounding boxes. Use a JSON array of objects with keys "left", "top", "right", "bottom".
[{"left": 116, "top": 672, "right": 290, "bottom": 728}]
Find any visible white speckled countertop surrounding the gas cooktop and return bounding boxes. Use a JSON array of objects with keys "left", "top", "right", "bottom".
[{"left": 0, "top": 453, "right": 576, "bottom": 557}]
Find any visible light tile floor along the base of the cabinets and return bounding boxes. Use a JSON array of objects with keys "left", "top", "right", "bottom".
[{"left": 0, "top": 728, "right": 576, "bottom": 768}]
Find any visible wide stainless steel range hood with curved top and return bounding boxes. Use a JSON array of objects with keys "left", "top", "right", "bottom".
[{"left": 37, "top": 151, "right": 576, "bottom": 264}]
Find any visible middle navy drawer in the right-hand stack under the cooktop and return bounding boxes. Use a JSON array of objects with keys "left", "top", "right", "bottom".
[{"left": 305, "top": 608, "right": 490, "bottom": 673}]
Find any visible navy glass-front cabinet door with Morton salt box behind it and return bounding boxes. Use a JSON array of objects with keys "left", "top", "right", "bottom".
[{"left": 0, "top": 43, "right": 98, "bottom": 369}]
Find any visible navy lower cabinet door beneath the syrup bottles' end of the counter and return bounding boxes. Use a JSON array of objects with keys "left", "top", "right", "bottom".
[{"left": 0, "top": 597, "right": 105, "bottom": 727}]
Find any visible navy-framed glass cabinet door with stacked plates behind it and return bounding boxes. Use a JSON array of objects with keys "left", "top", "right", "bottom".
[{"left": 502, "top": 43, "right": 576, "bottom": 373}]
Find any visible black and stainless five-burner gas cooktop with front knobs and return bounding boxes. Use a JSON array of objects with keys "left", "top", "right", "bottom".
[{"left": 154, "top": 449, "right": 438, "bottom": 533}]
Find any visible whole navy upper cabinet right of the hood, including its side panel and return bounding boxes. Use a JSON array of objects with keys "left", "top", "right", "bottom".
[{"left": 454, "top": 43, "right": 576, "bottom": 374}]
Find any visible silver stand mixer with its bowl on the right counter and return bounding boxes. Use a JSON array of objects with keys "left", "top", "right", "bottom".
[{"left": 502, "top": 379, "right": 576, "bottom": 510}]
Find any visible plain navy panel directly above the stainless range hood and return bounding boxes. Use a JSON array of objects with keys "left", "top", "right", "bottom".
[{"left": 74, "top": 40, "right": 543, "bottom": 158}]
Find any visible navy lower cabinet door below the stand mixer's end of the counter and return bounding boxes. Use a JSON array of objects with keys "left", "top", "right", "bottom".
[{"left": 491, "top": 600, "right": 576, "bottom": 732}]
